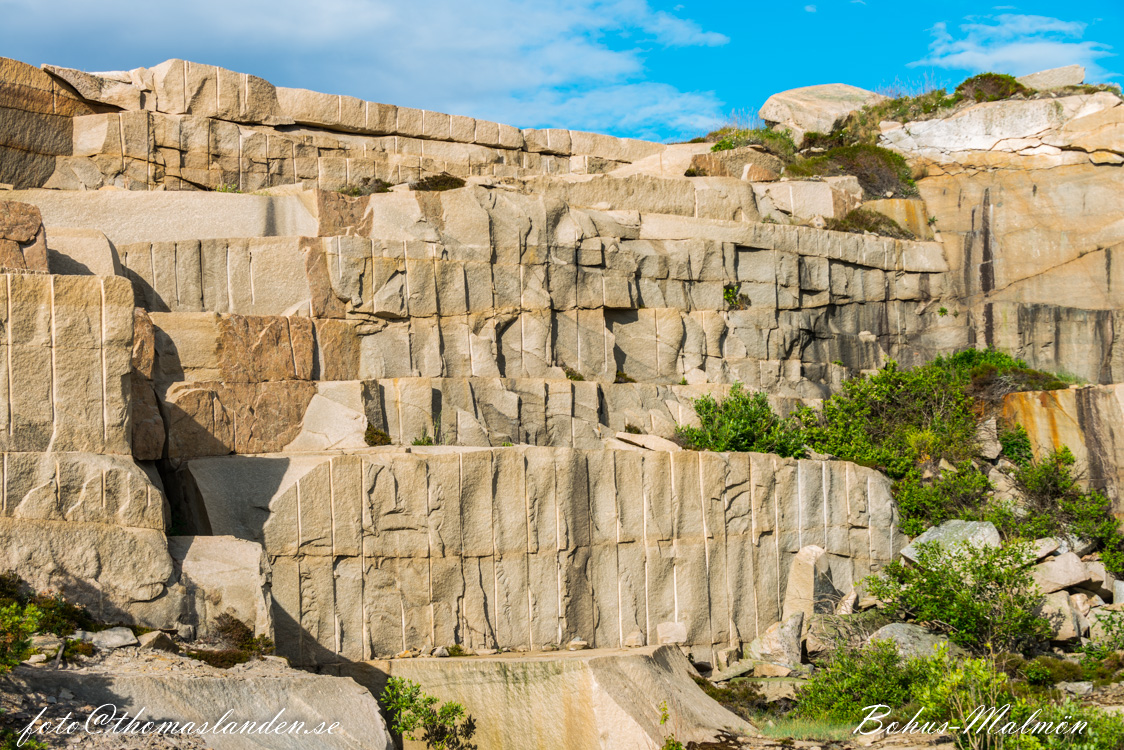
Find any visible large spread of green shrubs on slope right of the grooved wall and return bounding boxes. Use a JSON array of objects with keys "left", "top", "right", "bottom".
[{"left": 677, "top": 350, "right": 1124, "bottom": 572}]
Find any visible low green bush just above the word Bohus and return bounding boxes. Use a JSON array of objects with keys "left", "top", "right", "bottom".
[{"left": 796, "top": 641, "right": 921, "bottom": 722}]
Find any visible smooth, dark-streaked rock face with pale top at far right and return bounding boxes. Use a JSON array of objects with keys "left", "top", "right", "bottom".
[{"left": 882, "top": 91, "right": 1124, "bottom": 383}]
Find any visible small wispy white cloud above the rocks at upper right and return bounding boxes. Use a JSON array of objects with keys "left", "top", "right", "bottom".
[{"left": 909, "top": 13, "right": 1114, "bottom": 80}]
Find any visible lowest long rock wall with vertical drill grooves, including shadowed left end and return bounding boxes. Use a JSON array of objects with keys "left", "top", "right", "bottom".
[{"left": 182, "top": 446, "right": 904, "bottom": 663}]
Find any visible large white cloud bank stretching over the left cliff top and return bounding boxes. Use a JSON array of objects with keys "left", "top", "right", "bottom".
[{"left": 0, "top": 0, "right": 729, "bottom": 137}]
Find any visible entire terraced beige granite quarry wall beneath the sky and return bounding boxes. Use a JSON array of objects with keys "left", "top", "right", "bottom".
[{"left": 0, "top": 51, "right": 1124, "bottom": 747}]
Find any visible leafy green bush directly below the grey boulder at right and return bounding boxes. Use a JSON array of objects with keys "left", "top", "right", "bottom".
[{"left": 864, "top": 542, "right": 1052, "bottom": 652}]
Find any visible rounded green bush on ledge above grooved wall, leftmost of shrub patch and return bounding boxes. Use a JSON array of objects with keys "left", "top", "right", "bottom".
[{"left": 676, "top": 382, "right": 805, "bottom": 458}]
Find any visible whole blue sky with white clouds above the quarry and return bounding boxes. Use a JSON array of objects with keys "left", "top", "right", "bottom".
[{"left": 0, "top": 0, "right": 1124, "bottom": 141}]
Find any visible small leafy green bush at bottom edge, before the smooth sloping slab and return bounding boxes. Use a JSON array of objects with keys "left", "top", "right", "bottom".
[{"left": 380, "top": 677, "right": 477, "bottom": 750}]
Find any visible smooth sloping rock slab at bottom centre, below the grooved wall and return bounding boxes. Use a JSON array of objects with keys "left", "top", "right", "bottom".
[{"left": 339, "top": 647, "right": 750, "bottom": 750}]
